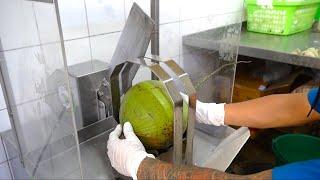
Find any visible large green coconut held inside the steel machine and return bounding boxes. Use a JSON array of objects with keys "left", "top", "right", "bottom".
[{"left": 119, "top": 80, "right": 188, "bottom": 149}]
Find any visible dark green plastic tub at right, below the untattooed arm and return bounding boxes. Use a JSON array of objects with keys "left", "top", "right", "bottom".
[{"left": 272, "top": 134, "right": 320, "bottom": 165}]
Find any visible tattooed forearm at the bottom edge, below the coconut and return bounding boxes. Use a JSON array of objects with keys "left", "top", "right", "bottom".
[{"left": 137, "top": 158, "right": 272, "bottom": 180}]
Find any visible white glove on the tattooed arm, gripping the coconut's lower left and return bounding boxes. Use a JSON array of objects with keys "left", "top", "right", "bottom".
[{"left": 107, "top": 122, "right": 154, "bottom": 179}]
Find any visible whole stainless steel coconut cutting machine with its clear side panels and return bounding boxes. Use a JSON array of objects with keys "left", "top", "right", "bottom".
[{"left": 0, "top": 1, "right": 249, "bottom": 179}]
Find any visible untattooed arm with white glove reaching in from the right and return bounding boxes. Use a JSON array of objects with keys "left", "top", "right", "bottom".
[{"left": 188, "top": 92, "right": 320, "bottom": 129}]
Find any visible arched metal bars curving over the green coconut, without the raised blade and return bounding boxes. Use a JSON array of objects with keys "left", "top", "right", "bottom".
[{"left": 110, "top": 56, "right": 196, "bottom": 165}]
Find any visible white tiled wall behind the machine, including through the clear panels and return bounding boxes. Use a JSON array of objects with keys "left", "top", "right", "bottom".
[{"left": 0, "top": 0, "right": 243, "bottom": 177}]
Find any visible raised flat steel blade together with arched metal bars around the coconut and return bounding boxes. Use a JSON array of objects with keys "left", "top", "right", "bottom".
[{"left": 110, "top": 3, "right": 196, "bottom": 165}]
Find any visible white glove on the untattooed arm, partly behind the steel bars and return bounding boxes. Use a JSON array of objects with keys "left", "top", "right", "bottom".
[{"left": 180, "top": 93, "right": 225, "bottom": 126}]
